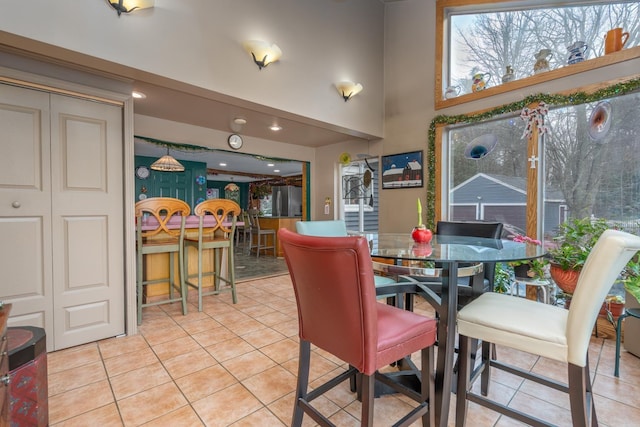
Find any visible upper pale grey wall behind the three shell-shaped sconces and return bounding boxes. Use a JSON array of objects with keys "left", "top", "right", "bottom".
[{"left": 0, "top": 0, "right": 384, "bottom": 136}]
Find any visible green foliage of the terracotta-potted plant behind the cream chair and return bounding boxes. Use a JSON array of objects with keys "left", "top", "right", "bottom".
[{"left": 549, "top": 218, "right": 613, "bottom": 270}]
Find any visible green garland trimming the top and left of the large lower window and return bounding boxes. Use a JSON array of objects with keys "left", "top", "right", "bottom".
[{"left": 426, "top": 78, "right": 640, "bottom": 229}]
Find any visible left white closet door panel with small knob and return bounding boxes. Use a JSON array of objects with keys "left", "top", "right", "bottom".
[{"left": 0, "top": 84, "right": 53, "bottom": 338}]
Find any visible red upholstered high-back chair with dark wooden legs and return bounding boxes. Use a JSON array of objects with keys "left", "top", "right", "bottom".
[{"left": 278, "top": 229, "right": 436, "bottom": 426}]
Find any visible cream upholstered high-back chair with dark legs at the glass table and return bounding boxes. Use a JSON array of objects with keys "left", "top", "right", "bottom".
[{"left": 456, "top": 230, "right": 640, "bottom": 426}]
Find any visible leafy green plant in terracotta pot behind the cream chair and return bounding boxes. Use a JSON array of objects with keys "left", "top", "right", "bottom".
[{"left": 549, "top": 218, "right": 611, "bottom": 294}]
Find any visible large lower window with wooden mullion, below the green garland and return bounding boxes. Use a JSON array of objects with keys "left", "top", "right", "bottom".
[{"left": 441, "top": 79, "right": 640, "bottom": 241}]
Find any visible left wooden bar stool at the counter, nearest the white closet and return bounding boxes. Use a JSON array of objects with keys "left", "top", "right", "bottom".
[{"left": 135, "top": 197, "right": 191, "bottom": 325}]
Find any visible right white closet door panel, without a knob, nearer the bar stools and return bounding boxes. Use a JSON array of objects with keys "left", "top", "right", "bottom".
[{"left": 51, "top": 95, "right": 125, "bottom": 349}]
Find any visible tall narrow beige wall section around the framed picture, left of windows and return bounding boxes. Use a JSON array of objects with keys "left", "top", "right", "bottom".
[{"left": 380, "top": 0, "right": 436, "bottom": 233}]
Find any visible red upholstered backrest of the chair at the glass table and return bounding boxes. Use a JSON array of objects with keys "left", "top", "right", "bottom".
[{"left": 278, "top": 229, "right": 378, "bottom": 372}]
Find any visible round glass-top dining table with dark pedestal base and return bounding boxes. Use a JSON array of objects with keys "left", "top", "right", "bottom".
[{"left": 356, "top": 232, "right": 545, "bottom": 427}]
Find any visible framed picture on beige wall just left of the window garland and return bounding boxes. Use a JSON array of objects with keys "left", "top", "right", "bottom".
[{"left": 382, "top": 151, "right": 424, "bottom": 189}]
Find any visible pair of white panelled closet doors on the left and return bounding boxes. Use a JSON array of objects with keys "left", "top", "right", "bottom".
[{"left": 0, "top": 84, "right": 125, "bottom": 351}]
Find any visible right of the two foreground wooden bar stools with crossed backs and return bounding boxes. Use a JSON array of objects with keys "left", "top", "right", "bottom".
[{"left": 184, "top": 199, "right": 241, "bottom": 311}]
